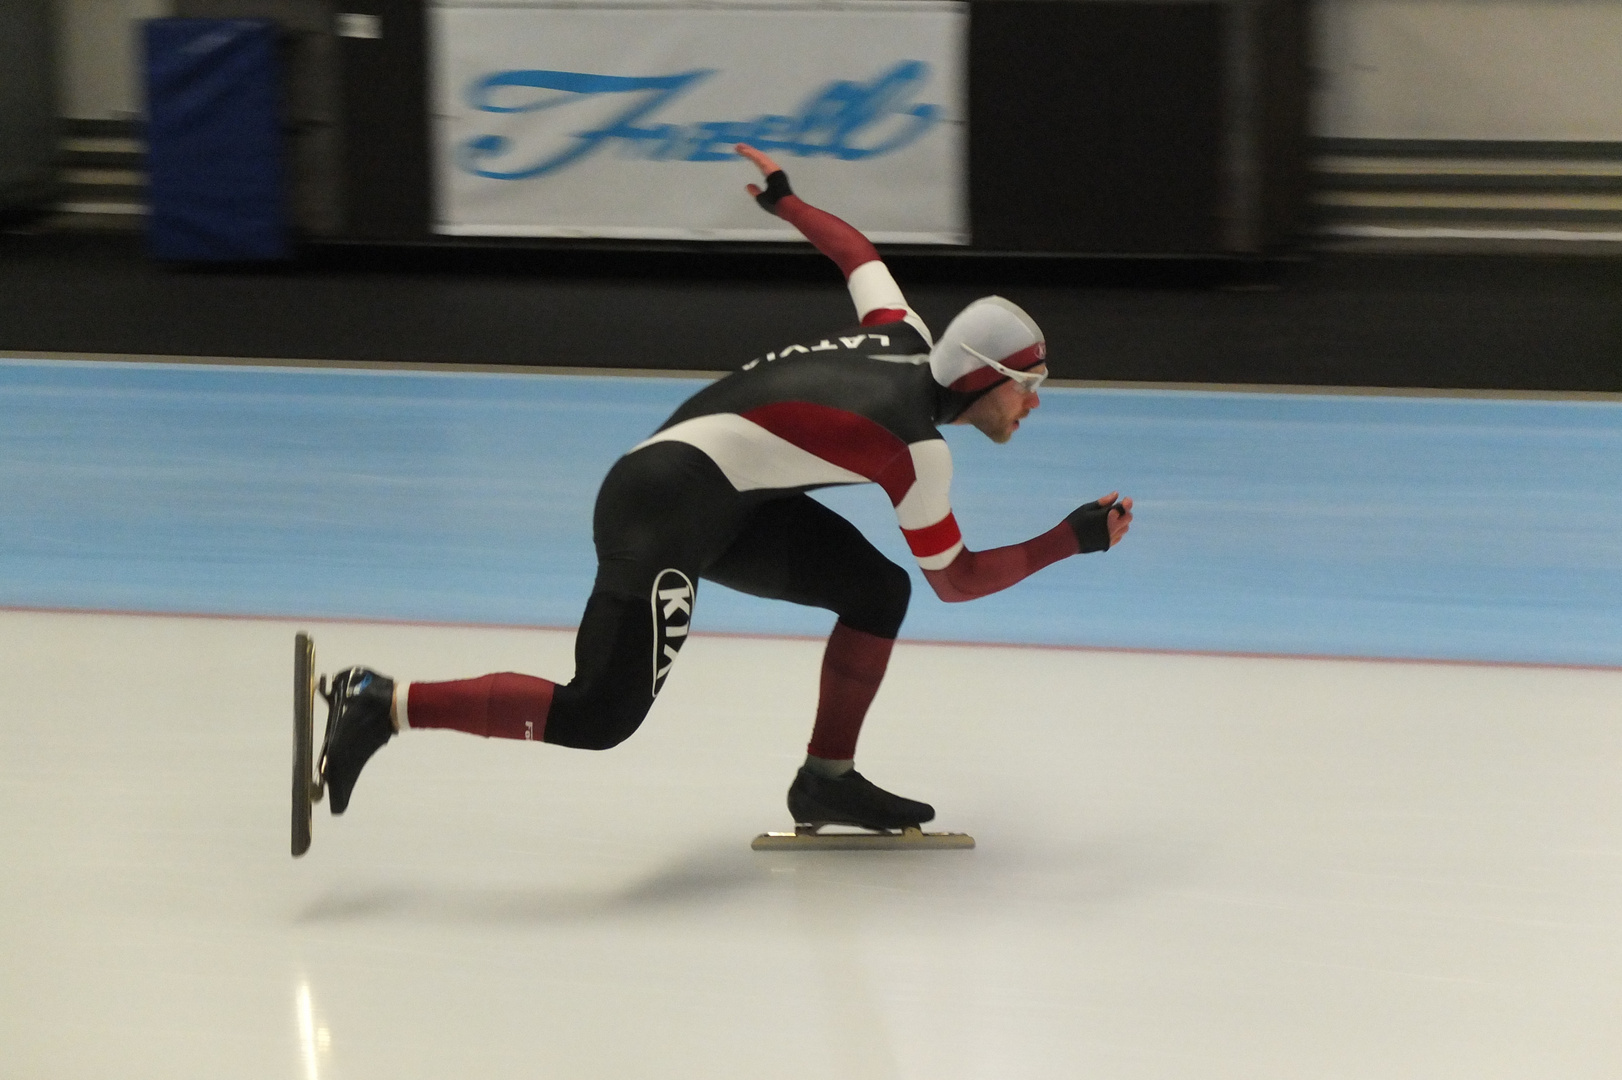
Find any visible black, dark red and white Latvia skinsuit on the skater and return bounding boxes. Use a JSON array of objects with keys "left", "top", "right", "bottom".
[{"left": 404, "top": 187, "right": 1080, "bottom": 759}]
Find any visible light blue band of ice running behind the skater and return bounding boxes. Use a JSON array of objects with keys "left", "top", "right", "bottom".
[{"left": 0, "top": 362, "right": 1622, "bottom": 665}]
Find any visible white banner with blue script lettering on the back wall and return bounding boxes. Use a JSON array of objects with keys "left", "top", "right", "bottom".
[{"left": 431, "top": 0, "right": 968, "bottom": 243}]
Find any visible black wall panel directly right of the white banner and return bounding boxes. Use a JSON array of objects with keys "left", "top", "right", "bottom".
[{"left": 968, "top": 0, "right": 1226, "bottom": 253}]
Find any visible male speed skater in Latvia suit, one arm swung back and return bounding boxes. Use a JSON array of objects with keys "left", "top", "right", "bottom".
[{"left": 320, "top": 146, "right": 1132, "bottom": 830}]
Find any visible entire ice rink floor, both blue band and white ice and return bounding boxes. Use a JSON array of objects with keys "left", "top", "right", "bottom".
[{"left": 0, "top": 362, "right": 1622, "bottom": 1080}]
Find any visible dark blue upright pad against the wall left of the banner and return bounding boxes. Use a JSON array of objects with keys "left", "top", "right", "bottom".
[{"left": 146, "top": 19, "right": 290, "bottom": 261}]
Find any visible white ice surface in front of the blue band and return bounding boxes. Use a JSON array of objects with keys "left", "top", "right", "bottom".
[{"left": 0, "top": 613, "right": 1622, "bottom": 1080}]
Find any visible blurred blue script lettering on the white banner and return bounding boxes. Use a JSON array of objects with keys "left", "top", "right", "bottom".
[{"left": 457, "top": 60, "right": 942, "bottom": 180}]
